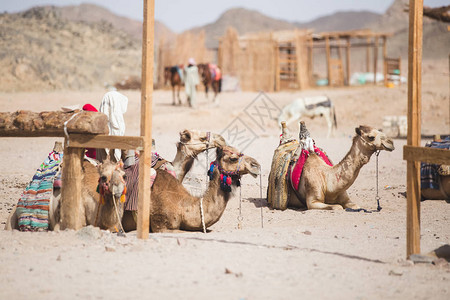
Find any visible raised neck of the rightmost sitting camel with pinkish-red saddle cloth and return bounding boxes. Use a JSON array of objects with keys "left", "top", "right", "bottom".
[{"left": 331, "top": 136, "right": 374, "bottom": 190}]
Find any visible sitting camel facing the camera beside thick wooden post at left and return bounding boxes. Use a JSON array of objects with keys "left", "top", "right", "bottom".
[{"left": 5, "top": 159, "right": 126, "bottom": 231}]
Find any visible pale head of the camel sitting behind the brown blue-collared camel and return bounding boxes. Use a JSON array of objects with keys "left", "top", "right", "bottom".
[{"left": 177, "top": 129, "right": 227, "bottom": 157}]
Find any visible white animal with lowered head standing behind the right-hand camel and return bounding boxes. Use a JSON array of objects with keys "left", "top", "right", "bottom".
[{"left": 278, "top": 96, "right": 337, "bottom": 137}]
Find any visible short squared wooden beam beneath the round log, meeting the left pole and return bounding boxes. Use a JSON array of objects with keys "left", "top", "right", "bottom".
[{"left": 69, "top": 134, "right": 144, "bottom": 151}]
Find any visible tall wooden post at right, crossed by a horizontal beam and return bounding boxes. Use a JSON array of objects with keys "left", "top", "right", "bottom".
[{"left": 406, "top": 0, "right": 423, "bottom": 257}]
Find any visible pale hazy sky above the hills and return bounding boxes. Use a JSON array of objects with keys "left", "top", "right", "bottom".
[{"left": 0, "top": 0, "right": 449, "bottom": 32}]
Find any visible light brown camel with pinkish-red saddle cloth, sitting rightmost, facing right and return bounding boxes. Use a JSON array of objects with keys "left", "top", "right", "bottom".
[{"left": 289, "top": 126, "right": 394, "bottom": 210}]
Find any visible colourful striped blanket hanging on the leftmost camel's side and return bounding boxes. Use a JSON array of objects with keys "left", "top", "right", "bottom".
[{"left": 16, "top": 152, "right": 63, "bottom": 231}]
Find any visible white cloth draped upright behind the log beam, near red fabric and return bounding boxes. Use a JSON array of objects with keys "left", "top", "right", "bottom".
[{"left": 99, "top": 91, "right": 128, "bottom": 161}]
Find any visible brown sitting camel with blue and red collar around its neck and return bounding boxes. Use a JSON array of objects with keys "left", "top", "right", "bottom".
[{"left": 123, "top": 146, "right": 260, "bottom": 232}]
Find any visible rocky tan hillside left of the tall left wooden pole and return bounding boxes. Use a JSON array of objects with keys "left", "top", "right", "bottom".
[{"left": 0, "top": 7, "right": 141, "bottom": 92}]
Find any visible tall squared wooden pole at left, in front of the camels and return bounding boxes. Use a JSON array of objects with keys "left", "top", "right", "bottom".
[{"left": 137, "top": 0, "right": 155, "bottom": 239}]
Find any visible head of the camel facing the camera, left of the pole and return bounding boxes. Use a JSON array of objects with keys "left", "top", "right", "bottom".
[{"left": 97, "top": 160, "right": 126, "bottom": 199}]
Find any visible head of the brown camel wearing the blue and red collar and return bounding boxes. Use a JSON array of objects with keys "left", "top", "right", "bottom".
[{"left": 216, "top": 146, "right": 260, "bottom": 177}]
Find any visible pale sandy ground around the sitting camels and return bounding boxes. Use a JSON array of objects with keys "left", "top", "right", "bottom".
[{"left": 0, "top": 61, "right": 450, "bottom": 299}]
